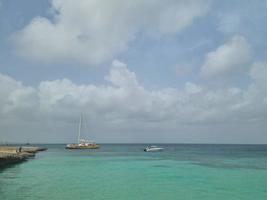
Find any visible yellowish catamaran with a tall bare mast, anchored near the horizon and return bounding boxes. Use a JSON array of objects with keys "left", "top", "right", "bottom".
[{"left": 66, "top": 114, "right": 99, "bottom": 149}]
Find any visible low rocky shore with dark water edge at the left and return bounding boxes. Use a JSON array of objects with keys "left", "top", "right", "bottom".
[{"left": 0, "top": 146, "right": 47, "bottom": 167}]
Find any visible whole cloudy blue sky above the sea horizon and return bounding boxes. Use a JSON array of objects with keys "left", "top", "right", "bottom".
[{"left": 0, "top": 0, "right": 267, "bottom": 144}]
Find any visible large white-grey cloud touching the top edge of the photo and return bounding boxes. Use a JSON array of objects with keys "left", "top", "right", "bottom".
[{"left": 13, "top": 0, "right": 209, "bottom": 64}]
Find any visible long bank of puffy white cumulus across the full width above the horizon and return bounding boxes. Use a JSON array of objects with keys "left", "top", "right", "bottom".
[{"left": 0, "top": 61, "right": 267, "bottom": 126}]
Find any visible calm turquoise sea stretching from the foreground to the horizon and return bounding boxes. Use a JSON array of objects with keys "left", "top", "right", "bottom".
[{"left": 0, "top": 144, "right": 267, "bottom": 200}]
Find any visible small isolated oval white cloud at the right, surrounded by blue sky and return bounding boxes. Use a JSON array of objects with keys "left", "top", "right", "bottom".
[{"left": 201, "top": 36, "right": 251, "bottom": 77}]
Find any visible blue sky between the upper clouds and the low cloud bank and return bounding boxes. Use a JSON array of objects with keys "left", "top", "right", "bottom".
[{"left": 0, "top": 0, "right": 267, "bottom": 87}]
